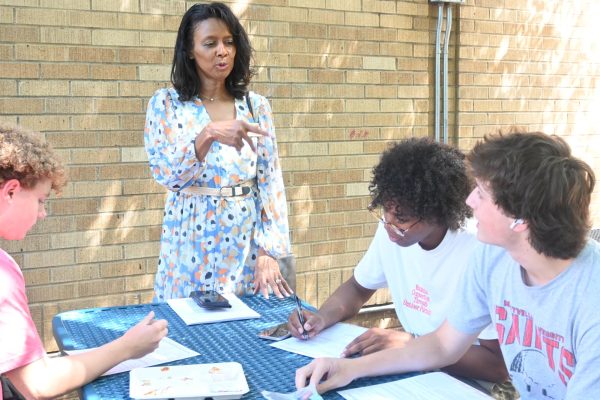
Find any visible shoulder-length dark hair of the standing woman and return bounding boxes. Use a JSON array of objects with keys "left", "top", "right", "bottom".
[{"left": 171, "top": 3, "right": 254, "bottom": 101}]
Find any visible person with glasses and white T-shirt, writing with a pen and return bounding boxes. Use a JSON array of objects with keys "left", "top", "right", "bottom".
[{"left": 288, "top": 138, "right": 507, "bottom": 382}]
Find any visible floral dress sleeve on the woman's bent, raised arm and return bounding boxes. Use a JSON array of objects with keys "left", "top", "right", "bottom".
[{"left": 144, "top": 89, "right": 204, "bottom": 191}]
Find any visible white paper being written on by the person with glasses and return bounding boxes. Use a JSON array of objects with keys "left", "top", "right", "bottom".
[{"left": 271, "top": 322, "right": 367, "bottom": 358}]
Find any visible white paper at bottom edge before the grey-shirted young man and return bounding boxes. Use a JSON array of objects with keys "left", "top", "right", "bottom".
[{"left": 338, "top": 372, "right": 492, "bottom": 400}]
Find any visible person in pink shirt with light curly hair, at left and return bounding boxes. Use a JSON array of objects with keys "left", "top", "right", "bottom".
[{"left": 0, "top": 123, "right": 167, "bottom": 400}]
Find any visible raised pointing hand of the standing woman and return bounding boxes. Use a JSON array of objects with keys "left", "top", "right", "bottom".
[{"left": 200, "top": 119, "right": 269, "bottom": 151}]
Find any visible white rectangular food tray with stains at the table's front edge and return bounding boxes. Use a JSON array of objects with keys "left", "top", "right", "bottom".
[{"left": 129, "top": 362, "right": 250, "bottom": 400}]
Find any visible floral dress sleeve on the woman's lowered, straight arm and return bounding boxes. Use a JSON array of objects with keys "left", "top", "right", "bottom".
[{"left": 251, "top": 95, "right": 291, "bottom": 258}]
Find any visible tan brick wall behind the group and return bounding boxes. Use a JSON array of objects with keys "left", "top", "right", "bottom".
[{"left": 0, "top": 0, "right": 600, "bottom": 350}]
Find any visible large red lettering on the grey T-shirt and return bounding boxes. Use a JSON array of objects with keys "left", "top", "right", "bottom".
[{"left": 496, "top": 300, "right": 575, "bottom": 386}]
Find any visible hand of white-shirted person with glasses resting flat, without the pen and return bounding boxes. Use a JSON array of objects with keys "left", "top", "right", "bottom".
[{"left": 340, "top": 328, "right": 413, "bottom": 357}]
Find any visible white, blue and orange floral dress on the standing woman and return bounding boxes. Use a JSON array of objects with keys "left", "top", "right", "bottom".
[{"left": 144, "top": 88, "right": 290, "bottom": 301}]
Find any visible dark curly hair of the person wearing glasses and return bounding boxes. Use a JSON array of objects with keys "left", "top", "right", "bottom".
[{"left": 369, "top": 138, "right": 472, "bottom": 230}]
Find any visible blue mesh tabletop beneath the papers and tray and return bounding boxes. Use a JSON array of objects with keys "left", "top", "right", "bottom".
[{"left": 52, "top": 296, "right": 418, "bottom": 399}]
